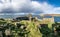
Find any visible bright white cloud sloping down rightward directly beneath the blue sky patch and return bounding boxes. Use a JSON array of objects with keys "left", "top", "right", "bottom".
[{"left": 32, "top": 1, "right": 60, "bottom": 14}]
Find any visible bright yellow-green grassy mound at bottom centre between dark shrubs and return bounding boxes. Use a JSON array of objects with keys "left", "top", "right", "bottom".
[{"left": 20, "top": 22, "right": 42, "bottom": 37}]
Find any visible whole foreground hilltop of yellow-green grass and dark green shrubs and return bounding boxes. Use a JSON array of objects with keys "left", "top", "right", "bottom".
[{"left": 0, "top": 19, "right": 60, "bottom": 37}]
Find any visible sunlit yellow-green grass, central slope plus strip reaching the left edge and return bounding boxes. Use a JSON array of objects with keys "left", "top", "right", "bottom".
[{"left": 0, "top": 20, "right": 56, "bottom": 37}]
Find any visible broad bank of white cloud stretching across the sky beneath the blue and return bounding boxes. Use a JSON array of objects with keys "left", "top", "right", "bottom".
[{"left": 0, "top": 0, "right": 60, "bottom": 14}]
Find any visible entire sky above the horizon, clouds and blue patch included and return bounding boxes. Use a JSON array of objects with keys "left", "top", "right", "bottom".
[{"left": 0, "top": 0, "right": 60, "bottom": 15}]
